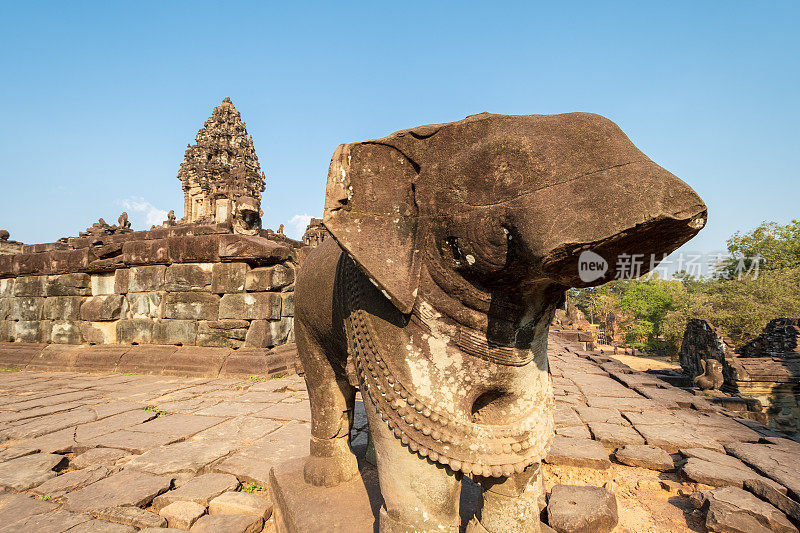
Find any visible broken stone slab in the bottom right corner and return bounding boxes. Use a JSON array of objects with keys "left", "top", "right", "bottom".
[{"left": 693, "top": 487, "right": 797, "bottom": 533}]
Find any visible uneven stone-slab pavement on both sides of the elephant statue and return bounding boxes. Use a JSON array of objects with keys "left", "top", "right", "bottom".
[{"left": 0, "top": 337, "right": 800, "bottom": 533}]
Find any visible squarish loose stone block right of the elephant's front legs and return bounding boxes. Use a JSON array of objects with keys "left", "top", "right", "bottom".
[{"left": 547, "top": 485, "right": 618, "bottom": 533}]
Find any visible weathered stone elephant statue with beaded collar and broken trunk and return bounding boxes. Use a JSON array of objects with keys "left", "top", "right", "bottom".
[{"left": 295, "top": 113, "right": 706, "bottom": 533}]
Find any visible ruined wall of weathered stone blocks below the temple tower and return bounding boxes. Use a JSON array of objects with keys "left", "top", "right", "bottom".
[{"left": 0, "top": 225, "right": 297, "bottom": 348}]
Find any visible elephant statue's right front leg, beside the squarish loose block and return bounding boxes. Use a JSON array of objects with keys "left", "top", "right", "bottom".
[{"left": 467, "top": 464, "right": 544, "bottom": 533}]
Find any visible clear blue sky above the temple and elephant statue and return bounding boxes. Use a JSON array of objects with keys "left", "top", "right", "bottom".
[{"left": 0, "top": 1, "right": 800, "bottom": 266}]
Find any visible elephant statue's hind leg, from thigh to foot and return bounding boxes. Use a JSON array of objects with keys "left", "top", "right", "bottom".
[{"left": 295, "top": 320, "right": 358, "bottom": 486}]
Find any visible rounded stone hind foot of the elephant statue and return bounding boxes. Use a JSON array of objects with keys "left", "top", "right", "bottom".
[{"left": 303, "top": 436, "right": 358, "bottom": 487}]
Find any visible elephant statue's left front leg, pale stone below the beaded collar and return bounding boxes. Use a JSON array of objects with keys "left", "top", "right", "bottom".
[{"left": 362, "top": 394, "right": 461, "bottom": 533}]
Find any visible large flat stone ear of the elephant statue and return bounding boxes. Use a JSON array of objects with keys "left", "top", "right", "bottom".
[{"left": 323, "top": 141, "right": 420, "bottom": 313}]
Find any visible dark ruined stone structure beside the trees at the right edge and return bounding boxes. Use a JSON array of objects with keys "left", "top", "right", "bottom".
[{"left": 680, "top": 318, "right": 800, "bottom": 434}]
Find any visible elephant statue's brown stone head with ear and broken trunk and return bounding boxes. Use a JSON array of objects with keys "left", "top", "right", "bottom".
[{"left": 324, "top": 113, "right": 706, "bottom": 340}]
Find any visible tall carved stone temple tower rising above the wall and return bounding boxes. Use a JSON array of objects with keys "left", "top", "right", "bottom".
[{"left": 178, "top": 96, "right": 265, "bottom": 222}]
